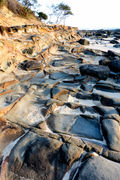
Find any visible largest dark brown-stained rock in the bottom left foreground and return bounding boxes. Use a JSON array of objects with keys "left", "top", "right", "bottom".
[{"left": 8, "top": 132, "right": 70, "bottom": 180}]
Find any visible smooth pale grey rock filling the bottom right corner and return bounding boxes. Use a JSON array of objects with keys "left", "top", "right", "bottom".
[{"left": 75, "top": 156, "right": 120, "bottom": 180}]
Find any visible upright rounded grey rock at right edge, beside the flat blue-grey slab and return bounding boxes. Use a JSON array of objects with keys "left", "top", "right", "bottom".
[{"left": 102, "top": 119, "right": 120, "bottom": 151}]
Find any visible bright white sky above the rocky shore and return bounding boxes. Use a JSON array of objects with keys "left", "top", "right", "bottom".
[{"left": 38, "top": 0, "right": 120, "bottom": 29}]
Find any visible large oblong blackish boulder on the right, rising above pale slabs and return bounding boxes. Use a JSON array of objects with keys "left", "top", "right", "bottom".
[{"left": 80, "top": 64, "right": 110, "bottom": 79}]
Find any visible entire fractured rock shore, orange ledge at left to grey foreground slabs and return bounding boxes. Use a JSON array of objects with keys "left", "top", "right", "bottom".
[{"left": 0, "top": 8, "right": 120, "bottom": 180}]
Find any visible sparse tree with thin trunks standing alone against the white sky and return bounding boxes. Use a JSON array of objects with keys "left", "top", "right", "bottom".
[{"left": 51, "top": 3, "right": 73, "bottom": 24}]
